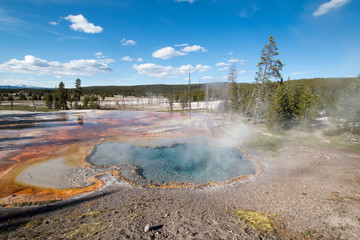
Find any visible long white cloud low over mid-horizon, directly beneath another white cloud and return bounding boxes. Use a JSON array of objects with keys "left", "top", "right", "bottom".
[{"left": 132, "top": 63, "right": 210, "bottom": 78}]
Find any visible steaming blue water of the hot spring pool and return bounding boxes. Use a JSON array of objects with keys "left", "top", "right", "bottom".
[{"left": 88, "top": 142, "right": 256, "bottom": 184}]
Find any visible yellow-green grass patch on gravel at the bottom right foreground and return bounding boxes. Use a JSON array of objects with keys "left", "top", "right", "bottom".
[{"left": 235, "top": 210, "right": 276, "bottom": 232}]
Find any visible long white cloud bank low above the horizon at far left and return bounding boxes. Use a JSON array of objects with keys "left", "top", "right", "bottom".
[{"left": 0, "top": 55, "right": 113, "bottom": 77}]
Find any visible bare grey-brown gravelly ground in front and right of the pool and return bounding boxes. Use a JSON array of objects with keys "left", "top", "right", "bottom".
[{"left": 0, "top": 111, "right": 360, "bottom": 239}]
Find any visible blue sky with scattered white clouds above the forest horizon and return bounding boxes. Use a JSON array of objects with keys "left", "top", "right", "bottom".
[{"left": 0, "top": 0, "right": 360, "bottom": 88}]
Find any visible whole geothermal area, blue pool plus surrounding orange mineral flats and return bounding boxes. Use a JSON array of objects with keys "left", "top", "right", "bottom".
[{"left": 0, "top": 111, "right": 261, "bottom": 206}]
